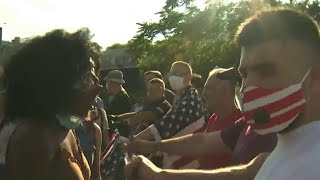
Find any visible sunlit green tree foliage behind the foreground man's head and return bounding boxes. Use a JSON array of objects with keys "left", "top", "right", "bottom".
[{"left": 128, "top": 0, "right": 320, "bottom": 77}]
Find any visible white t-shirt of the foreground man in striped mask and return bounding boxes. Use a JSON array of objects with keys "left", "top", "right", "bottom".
[{"left": 255, "top": 121, "right": 320, "bottom": 180}]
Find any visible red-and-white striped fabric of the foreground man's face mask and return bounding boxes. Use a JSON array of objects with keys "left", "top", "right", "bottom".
[{"left": 243, "top": 87, "right": 304, "bottom": 131}]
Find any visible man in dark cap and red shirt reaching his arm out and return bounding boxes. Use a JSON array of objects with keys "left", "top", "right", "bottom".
[{"left": 128, "top": 68, "right": 276, "bottom": 169}]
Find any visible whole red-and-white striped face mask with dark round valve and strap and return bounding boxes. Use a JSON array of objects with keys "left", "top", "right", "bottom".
[{"left": 236, "top": 69, "right": 311, "bottom": 135}]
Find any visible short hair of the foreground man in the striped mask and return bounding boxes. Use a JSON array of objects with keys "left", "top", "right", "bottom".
[{"left": 235, "top": 8, "right": 320, "bottom": 52}]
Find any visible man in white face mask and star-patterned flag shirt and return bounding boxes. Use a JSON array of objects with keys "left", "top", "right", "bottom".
[{"left": 129, "top": 61, "right": 205, "bottom": 168}]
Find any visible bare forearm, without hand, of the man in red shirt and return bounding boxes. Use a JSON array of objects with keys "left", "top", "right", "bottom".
[{"left": 156, "top": 133, "right": 229, "bottom": 156}]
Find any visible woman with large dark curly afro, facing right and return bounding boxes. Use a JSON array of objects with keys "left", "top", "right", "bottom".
[{"left": 5, "top": 29, "right": 100, "bottom": 180}]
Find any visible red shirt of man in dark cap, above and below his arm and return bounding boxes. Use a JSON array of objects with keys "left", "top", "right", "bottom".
[{"left": 173, "top": 110, "right": 243, "bottom": 169}]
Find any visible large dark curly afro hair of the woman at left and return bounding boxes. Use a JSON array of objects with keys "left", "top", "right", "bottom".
[{"left": 5, "top": 29, "right": 92, "bottom": 121}]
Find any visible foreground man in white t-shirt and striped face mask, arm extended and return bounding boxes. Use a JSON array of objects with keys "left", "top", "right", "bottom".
[{"left": 127, "top": 9, "right": 320, "bottom": 180}]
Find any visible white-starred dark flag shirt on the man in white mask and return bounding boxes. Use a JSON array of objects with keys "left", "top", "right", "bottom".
[{"left": 150, "top": 87, "right": 205, "bottom": 168}]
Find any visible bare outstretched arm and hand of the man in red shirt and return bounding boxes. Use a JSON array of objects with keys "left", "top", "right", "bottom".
[{"left": 128, "top": 129, "right": 231, "bottom": 156}]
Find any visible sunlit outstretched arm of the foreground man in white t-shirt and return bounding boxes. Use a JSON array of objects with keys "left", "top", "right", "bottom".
[{"left": 125, "top": 153, "right": 269, "bottom": 180}]
